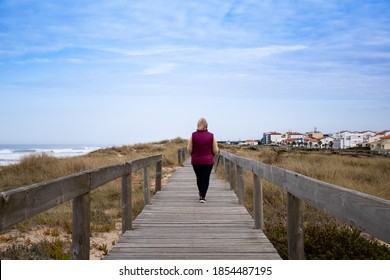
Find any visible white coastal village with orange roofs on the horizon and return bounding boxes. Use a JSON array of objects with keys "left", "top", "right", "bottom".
[{"left": 224, "top": 128, "right": 390, "bottom": 152}]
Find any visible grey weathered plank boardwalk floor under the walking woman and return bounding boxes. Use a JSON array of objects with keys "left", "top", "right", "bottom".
[{"left": 105, "top": 160, "right": 281, "bottom": 260}]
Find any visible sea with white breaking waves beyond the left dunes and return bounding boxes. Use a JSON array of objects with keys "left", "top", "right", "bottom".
[{"left": 0, "top": 144, "right": 108, "bottom": 166}]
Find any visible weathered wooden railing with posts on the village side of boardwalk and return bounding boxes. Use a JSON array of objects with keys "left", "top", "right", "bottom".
[{"left": 220, "top": 151, "right": 390, "bottom": 259}]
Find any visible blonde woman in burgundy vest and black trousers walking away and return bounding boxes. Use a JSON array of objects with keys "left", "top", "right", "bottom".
[{"left": 187, "top": 118, "right": 219, "bottom": 203}]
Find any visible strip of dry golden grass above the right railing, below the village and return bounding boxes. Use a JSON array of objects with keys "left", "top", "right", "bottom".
[{"left": 222, "top": 144, "right": 390, "bottom": 199}]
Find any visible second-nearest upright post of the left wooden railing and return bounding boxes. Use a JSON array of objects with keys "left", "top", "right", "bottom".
[{"left": 122, "top": 168, "right": 133, "bottom": 233}]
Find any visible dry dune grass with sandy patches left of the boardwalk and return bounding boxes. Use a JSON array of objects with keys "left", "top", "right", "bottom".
[{"left": 0, "top": 138, "right": 186, "bottom": 259}]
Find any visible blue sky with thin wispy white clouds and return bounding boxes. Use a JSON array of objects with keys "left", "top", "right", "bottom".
[{"left": 0, "top": 0, "right": 390, "bottom": 145}]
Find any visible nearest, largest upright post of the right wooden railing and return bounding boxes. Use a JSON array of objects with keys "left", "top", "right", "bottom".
[{"left": 287, "top": 192, "right": 305, "bottom": 260}]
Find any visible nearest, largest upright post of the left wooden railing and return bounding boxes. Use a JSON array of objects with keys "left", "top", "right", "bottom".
[{"left": 72, "top": 192, "right": 91, "bottom": 260}]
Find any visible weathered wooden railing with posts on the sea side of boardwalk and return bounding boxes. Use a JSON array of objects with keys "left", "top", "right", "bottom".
[{"left": 0, "top": 155, "right": 162, "bottom": 260}]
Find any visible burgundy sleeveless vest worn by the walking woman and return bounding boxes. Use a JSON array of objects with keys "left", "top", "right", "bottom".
[{"left": 191, "top": 130, "right": 214, "bottom": 164}]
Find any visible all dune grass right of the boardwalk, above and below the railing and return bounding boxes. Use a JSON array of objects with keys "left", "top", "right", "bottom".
[{"left": 219, "top": 146, "right": 390, "bottom": 259}]
